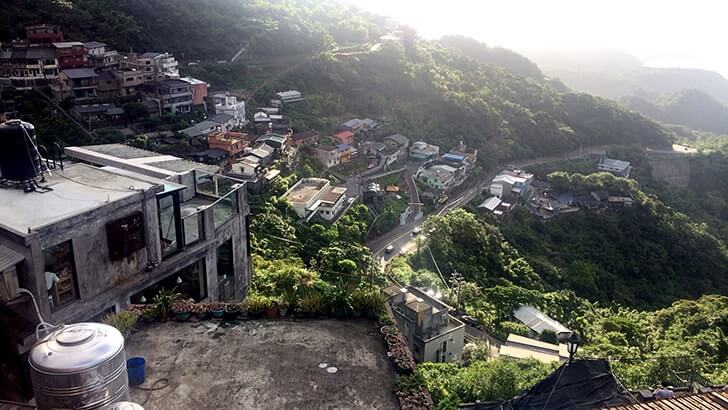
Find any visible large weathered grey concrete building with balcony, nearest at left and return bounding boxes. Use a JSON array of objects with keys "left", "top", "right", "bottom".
[{"left": 0, "top": 144, "right": 251, "bottom": 400}]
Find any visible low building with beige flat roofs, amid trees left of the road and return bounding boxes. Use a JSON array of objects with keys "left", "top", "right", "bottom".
[{"left": 281, "top": 178, "right": 346, "bottom": 221}]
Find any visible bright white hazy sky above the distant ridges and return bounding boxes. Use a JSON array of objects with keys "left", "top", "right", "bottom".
[{"left": 349, "top": 0, "right": 728, "bottom": 77}]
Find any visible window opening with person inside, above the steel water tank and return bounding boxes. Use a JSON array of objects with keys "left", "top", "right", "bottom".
[{"left": 43, "top": 241, "right": 78, "bottom": 310}]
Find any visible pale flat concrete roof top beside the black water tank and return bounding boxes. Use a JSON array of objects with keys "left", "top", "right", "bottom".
[{"left": 0, "top": 164, "right": 155, "bottom": 235}]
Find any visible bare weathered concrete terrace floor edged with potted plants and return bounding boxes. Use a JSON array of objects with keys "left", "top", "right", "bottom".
[{"left": 126, "top": 320, "right": 399, "bottom": 410}]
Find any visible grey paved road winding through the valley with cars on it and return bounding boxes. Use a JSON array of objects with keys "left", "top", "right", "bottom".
[{"left": 367, "top": 146, "right": 608, "bottom": 264}]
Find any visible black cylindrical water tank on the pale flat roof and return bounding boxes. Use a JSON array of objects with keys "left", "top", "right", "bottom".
[{"left": 0, "top": 120, "right": 41, "bottom": 181}]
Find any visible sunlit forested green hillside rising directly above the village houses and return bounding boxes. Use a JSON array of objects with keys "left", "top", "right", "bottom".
[{"left": 0, "top": 0, "right": 672, "bottom": 160}]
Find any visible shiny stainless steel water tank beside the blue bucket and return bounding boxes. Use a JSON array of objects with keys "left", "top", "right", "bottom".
[{"left": 29, "top": 323, "right": 129, "bottom": 409}]
